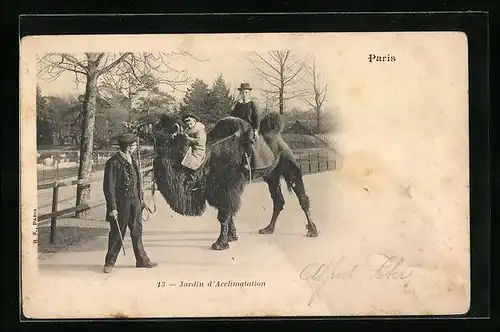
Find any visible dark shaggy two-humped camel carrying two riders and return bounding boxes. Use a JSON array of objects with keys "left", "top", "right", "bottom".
[{"left": 153, "top": 113, "right": 318, "bottom": 250}]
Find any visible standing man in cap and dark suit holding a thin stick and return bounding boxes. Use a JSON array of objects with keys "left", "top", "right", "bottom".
[{"left": 103, "top": 134, "right": 157, "bottom": 273}]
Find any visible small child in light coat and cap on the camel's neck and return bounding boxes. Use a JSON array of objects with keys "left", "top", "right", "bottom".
[{"left": 181, "top": 114, "right": 207, "bottom": 182}]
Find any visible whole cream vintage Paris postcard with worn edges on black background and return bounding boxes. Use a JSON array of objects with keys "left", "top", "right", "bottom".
[{"left": 20, "top": 32, "right": 471, "bottom": 319}]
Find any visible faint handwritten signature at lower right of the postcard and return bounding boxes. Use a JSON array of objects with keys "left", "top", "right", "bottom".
[{"left": 299, "top": 253, "right": 413, "bottom": 306}]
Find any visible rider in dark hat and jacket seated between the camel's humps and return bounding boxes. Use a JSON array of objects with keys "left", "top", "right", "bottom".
[{"left": 230, "top": 82, "right": 275, "bottom": 171}]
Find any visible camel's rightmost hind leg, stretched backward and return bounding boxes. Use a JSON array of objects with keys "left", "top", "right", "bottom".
[{"left": 283, "top": 162, "right": 318, "bottom": 237}]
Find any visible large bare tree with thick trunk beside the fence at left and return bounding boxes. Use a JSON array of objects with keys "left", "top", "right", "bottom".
[{"left": 38, "top": 52, "right": 196, "bottom": 216}]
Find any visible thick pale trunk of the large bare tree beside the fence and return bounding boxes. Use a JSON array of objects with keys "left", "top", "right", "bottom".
[{"left": 76, "top": 55, "right": 98, "bottom": 217}]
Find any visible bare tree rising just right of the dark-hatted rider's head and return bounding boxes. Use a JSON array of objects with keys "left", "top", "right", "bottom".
[{"left": 249, "top": 50, "right": 306, "bottom": 114}]
